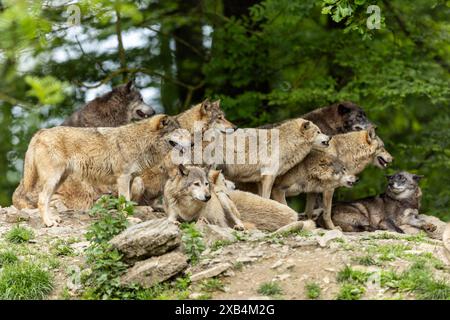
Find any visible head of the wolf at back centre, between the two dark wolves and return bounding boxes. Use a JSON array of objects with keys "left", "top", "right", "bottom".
[{"left": 200, "top": 99, "right": 237, "bottom": 133}]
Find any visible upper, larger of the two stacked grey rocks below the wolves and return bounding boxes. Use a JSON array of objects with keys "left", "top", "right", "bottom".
[{"left": 110, "top": 218, "right": 181, "bottom": 263}]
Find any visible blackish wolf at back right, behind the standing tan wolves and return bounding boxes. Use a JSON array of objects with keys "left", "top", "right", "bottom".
[{"left": 260, "top": 101, "right": 372, "bottom": 136}]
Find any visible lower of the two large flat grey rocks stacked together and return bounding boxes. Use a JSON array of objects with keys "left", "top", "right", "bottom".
[{"left": 121, "top": 252, "right": 188, "bottom": 288}]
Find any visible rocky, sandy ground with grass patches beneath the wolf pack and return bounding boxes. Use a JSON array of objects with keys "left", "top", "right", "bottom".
[{"left": 0, "top": 208, "right": 450, "bottom": 299}]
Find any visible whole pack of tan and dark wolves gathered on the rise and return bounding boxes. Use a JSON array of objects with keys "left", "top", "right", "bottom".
[{"left": 13, "top": 81, "right": 450, "bottom": 250}]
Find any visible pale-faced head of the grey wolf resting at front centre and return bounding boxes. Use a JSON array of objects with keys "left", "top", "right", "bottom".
[{"left": 177, "top": 164, "right": 211, "bottom": 202}]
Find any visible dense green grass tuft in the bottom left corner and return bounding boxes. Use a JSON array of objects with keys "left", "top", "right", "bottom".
[{"left": 0, "top": 262, "right": 53, "bottom": 300}]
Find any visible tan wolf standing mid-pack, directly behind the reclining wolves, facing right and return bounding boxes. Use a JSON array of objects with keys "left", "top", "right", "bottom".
[{"left": 218, "top": 118, "right": 331, "bottom": 198}]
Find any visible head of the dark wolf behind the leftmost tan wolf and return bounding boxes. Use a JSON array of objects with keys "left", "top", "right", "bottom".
[{"left": 111, "top": 81, "right": 156, "bottom": 123}]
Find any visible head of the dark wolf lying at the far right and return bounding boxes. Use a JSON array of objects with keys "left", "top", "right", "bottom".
[{"left": 386, "top": 171, "right": 423, "bottom": 200}]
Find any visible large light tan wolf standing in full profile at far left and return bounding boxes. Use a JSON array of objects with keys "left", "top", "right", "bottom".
[{"left": 24, "top": 115, "right": 191, "bottom": 226}]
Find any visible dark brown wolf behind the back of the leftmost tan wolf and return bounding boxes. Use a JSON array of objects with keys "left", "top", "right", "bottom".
[{"left": 61, "top": 81, "right": 155, "bottom": 127}]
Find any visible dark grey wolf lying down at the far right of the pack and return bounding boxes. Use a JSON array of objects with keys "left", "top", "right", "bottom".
[{"left": 332, "top": 171, "right": 436, "bottom": 233}]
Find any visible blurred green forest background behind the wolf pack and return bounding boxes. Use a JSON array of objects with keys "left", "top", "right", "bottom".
[{"left": 0, "top": 0, "right": 450, "bottom": 220}]
